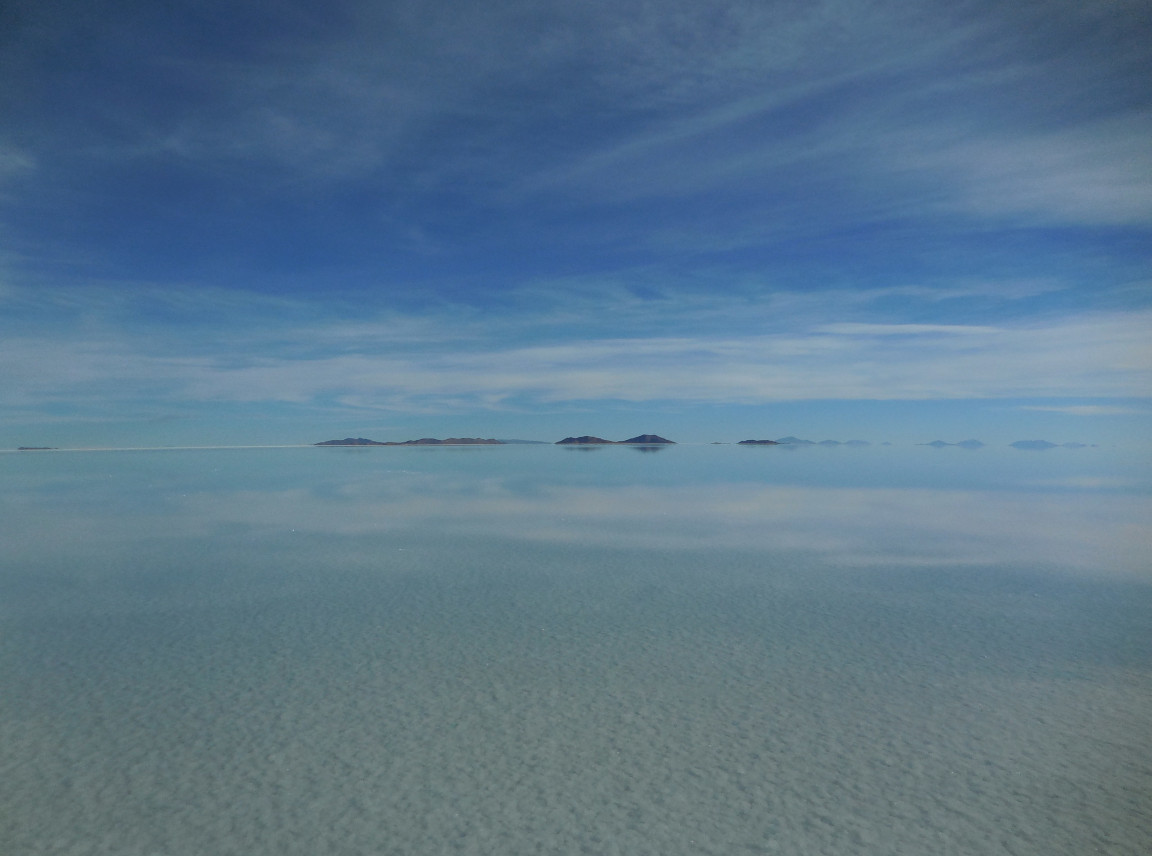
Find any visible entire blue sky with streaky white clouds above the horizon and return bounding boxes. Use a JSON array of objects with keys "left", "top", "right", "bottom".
[{"left": 0, "top": 0, "right": 1152, "bottom": 448}]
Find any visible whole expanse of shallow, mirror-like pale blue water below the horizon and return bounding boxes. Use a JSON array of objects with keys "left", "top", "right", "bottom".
[{"left": 0, "top": 446, "right": 1152, "bottom": 856}]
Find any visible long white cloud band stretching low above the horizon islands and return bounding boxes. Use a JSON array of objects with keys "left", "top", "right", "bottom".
[{"left": 0, "top": 288, "right": 1152, "bottom": 414}]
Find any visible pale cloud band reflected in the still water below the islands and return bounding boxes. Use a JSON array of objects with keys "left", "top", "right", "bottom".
[{"left": 81, "top": 474, "right": 1152, "bottom": 575}]
